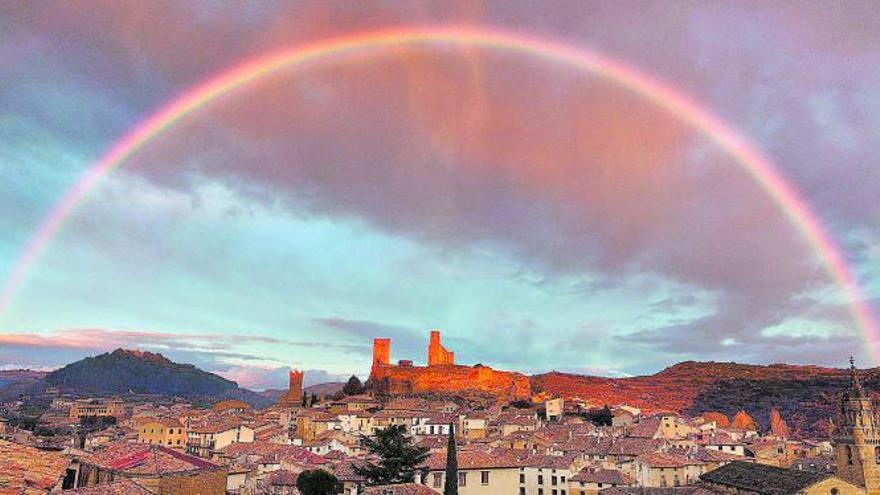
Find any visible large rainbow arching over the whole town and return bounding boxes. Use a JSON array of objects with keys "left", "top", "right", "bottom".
[{"left": 0, "top": 27, "right": 880, "bottom": 362}]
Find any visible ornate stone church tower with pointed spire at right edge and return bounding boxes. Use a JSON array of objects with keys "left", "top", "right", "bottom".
[{"left": 834, "top": 358, "right": 880, "bottom": 495}]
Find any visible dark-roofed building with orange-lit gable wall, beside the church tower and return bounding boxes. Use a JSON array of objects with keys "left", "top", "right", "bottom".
[{"left": 700, "top": 462, "right": 863, "bottom": 495}]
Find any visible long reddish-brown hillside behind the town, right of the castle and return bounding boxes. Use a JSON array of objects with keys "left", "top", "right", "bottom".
[{"left": 531, "top": 361, "right": 868, "bottom": 433}]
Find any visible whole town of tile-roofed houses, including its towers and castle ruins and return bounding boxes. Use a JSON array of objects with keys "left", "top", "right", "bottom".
[{"left": 0, "top": 332, "right": 880, "bottom": 495}]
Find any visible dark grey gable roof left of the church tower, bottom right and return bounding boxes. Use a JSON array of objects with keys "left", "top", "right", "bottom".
[{"left": 700, "top": 461, "right": 832, "bottom": 495}]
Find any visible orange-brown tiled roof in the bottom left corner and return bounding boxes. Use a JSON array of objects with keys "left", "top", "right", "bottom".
[{"left": 0, "top": 440, "right": 70, "bottom": 495}]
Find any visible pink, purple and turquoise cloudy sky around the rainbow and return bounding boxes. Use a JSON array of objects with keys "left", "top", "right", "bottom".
[{"left": 0, "top": 0, "right": 880, "bottom": 389}]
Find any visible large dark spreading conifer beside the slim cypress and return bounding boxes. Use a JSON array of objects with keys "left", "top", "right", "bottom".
[{"left": 354, "top": 425, "right": 429, "bottom": 485}]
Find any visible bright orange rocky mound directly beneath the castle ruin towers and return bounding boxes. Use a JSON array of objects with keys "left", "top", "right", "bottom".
[{"left": 368, "top": 364, "right": 531, "bottom": 401}]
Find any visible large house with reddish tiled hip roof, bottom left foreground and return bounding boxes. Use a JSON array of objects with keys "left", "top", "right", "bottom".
[{"left": 75, "top": 442, "right": 226, "bottom": 495}]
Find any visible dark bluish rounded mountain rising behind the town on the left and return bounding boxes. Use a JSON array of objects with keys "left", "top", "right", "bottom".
[{"left": 39, "top": 349, "right": 269, "bottom": 407}]
